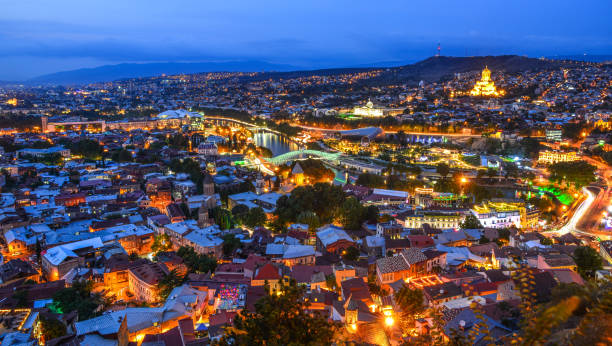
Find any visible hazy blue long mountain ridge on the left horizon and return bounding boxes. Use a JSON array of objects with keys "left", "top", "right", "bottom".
[{"left": 26, "top": 61, "right": 300, "bottom": 84}]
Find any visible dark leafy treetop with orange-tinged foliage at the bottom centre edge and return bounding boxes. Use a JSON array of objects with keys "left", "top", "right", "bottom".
[{"left": 219, "top": 280, "right": 338, "bottom": 345}]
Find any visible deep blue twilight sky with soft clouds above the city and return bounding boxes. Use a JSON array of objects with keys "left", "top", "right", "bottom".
[{"left": 0, "top": 0, "right": 612, "bottom": 80}]
